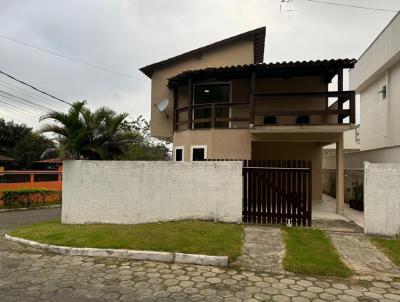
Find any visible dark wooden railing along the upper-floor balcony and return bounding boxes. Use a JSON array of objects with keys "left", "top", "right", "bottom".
[{"left": 174, "top": 91, "right": 355, "bottom": 131}]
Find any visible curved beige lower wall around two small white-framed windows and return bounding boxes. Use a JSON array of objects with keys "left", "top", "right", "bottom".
[{"left": 173, "top": 129, "right": 251, "bottom": 161}]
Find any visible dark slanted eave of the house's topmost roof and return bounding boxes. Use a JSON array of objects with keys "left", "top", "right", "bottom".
[{"left": 139, "top": 26, "right": 265, "bottom": 78}]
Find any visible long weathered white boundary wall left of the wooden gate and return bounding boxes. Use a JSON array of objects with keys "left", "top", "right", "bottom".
[{"left": 62, "top": 160, "right": 242, "bottom": 224}]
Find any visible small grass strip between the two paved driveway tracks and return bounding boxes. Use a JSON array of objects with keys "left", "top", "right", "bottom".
[{"left": 283, "top": 228, "right": 352, "bottom": 277}]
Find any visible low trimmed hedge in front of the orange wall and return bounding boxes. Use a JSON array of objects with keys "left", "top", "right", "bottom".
[{"left": 2, "top": 189, "right": 61, "bottom": 208}]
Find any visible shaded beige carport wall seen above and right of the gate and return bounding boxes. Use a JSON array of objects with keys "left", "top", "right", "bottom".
[{"left": 252, "top": 142, "right": 322, "bottom": 200}]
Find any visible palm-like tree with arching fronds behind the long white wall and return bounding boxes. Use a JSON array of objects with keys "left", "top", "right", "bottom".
[{"left": 40, "top": 101, "right": 136, "bottom": 159}]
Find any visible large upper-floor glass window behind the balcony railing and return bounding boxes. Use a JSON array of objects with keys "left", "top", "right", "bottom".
[{"left": 193, "top": 82, "right": 231, "bottom": 129}]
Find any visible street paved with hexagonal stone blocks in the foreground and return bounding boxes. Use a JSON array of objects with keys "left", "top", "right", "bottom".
[{"left": 0, "top": 211, "right": 400, "bottom": 301}]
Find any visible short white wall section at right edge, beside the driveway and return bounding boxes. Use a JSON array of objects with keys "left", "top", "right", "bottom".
[{"left": 364, "top": 162, "right": 400, "bottom": 236}]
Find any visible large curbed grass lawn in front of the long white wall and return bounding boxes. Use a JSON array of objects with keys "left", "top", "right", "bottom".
[{"left": 11, "top": 221, "right": 243, "bottom": 261}]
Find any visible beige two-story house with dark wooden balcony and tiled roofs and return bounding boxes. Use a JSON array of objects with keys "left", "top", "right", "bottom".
[{"left": 140, "top": 27, "right": 355, "bottom": 212}]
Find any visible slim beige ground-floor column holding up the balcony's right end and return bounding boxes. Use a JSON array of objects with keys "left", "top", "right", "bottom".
[{"left": 336, "top": 133, "right": 344, "bottom": 214}]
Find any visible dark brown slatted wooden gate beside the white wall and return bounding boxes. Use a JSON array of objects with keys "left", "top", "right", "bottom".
[{"left": 243, "top": 160, "right": 312, "bottom": 226}]
